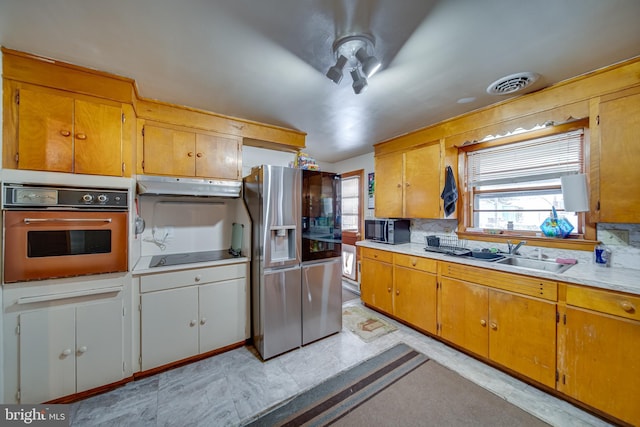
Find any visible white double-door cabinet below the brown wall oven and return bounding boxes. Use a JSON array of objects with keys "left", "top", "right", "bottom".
[{"left": 19, "top": 300, "right": 124, "bottom": 403}]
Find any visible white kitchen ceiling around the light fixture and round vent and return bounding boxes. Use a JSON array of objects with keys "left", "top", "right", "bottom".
[{"left": 0, "top": 0, "right": 640, "bottom": 162}]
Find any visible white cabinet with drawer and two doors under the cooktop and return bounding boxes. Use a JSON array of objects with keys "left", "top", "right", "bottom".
[{"left": 140, "top": 264, "right": 248, "bottom": 371}]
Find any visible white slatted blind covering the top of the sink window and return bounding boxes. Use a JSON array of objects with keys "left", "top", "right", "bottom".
[{"left": 467, "top": 129, "right": 584, "bottom": 187}]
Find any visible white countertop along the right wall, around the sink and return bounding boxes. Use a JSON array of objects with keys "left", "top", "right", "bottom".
[{"left": 356, "top": 240, "right": 640, "bottom": 295}]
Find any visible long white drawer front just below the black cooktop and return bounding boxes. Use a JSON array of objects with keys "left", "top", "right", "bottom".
[{"left": 140, "top": 263, "right": 247, "bottom": 293}]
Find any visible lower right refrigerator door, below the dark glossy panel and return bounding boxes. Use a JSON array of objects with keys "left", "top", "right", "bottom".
[{"left": 302, "top": 258, "right": 342, "bottom": 345}]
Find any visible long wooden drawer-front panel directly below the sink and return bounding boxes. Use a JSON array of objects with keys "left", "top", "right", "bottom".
[{"left": 439, "top": 262, "right": 558, "bottom": 301}]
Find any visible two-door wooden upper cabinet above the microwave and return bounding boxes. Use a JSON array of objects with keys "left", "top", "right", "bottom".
[{"left": 375, "top": 142, "right": 442, "bottom": 218}]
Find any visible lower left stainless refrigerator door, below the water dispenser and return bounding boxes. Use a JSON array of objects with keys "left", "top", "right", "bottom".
[{"left": 254, "top": 266, "right": 302, "bottom": 360}]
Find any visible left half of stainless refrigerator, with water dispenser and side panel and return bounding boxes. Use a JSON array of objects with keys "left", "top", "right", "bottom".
[{"left": 244, "top": 165, "right": 302, "bottom": 359}]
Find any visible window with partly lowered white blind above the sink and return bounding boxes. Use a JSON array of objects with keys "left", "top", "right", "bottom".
[{"left": 465, "top": 129, "right": 585, "bottom": 234}]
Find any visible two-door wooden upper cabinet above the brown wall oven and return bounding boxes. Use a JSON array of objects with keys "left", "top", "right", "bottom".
[{"left": 14, "top": 88, "right": 123, "bottom": 176}]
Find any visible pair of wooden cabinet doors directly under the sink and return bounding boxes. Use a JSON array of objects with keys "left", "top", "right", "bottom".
[{"left": 440, "top": 277, "right": 556, "bottom": 387}]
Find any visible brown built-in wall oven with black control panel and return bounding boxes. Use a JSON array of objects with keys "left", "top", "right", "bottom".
[{"left": 2, "top": 184, "right": 129, "bottom": 283}]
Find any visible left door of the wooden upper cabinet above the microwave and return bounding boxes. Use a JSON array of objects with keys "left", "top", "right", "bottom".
[{"left": 374, "top": 153, "right": 404, "bottom": 218}]
